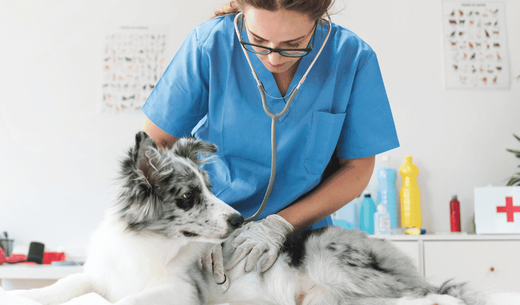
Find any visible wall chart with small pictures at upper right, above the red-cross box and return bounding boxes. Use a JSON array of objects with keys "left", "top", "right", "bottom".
[{"left": 443, "top": 1, "right": 510, "bottom": 89}]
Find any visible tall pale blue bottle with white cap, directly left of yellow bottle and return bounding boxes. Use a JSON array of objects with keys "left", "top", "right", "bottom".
[{"left": 377, "top": 156, "right": 397, "bottom": 228}]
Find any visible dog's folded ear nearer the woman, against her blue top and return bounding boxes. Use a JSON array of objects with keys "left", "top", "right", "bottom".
[{"left": 172, "top": 136, "right": 217, "bottom": 165}]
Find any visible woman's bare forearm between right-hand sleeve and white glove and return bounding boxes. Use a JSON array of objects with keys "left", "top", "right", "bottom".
[{"left": 278, "top": 156, "right": 375, "bottom": 229}]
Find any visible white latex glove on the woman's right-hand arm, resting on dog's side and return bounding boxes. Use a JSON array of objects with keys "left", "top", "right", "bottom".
[{"left": 226, "top": 214, "right": 294, "bottom": 272}]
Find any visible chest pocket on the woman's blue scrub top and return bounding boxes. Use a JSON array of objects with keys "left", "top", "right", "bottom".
[{"left": 303, "top": 111, "right": 346, "bottom": 174}]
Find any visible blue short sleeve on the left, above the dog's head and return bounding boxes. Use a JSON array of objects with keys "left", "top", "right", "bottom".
[{"left": 142, "top": 28, "right": 208, "bottom": 137}]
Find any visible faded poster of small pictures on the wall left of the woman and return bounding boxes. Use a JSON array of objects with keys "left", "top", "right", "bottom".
[{"left": 99, "top": 26, "right": 168, "bottom": 114}]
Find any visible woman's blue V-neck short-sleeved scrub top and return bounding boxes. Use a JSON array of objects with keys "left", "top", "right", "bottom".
[{"left": 142, "top": 15, "right": 399, "bottom": 228}]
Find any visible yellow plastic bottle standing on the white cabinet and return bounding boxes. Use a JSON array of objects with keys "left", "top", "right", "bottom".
[{"left": 399, "top": 156, "right": 421, "bottom": 228}]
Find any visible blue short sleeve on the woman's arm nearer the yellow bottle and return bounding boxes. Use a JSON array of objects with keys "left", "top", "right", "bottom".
[{"left": 337, "top": 51, "right": 399, "bottom": 159}]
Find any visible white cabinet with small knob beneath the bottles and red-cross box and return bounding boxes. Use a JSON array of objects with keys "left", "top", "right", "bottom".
[{"left": 382, "top": 235, "right": 520, "bottom": 292}]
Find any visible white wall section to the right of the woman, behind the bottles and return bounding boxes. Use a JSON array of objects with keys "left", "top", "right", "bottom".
[{"left": 335, "top": 0, "right": 520, "bottom": 232}]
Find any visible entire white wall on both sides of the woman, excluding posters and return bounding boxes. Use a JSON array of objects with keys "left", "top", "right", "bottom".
[{"left": 0, "top": 0, "right": 520, "bottom": 253}]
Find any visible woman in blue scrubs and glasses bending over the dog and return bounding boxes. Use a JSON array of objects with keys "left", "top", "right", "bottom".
[{"left": 142, "top": 0, "right": 399, "bottom": 271}]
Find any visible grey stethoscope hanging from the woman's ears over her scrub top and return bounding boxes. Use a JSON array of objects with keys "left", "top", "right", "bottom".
[{"left": 234, "top": 12, "right": 332, "bottom": 222}]
